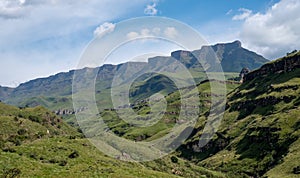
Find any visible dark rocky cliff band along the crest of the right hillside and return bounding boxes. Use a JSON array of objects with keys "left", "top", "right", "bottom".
[{"left": 244, "top": 52, "right": 300, "bottom": 82}]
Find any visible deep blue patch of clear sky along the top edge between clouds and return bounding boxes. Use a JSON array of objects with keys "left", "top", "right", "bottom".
[{"left": 157, "top": 0, "right": 273, "bottom": 23}]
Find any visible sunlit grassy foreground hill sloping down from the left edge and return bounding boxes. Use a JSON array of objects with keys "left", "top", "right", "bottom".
[{"left": 0, "top": 103, "right": 224, "bottom": 177}]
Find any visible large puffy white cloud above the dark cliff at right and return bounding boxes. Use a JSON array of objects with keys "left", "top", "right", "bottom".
[{"left": 239, "top": 0, "right": 300, "bottom": 59}]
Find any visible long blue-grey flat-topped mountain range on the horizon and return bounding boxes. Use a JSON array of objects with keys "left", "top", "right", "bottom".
[{"left": 0, "top": 41, "right": 268, "bottom": 109}]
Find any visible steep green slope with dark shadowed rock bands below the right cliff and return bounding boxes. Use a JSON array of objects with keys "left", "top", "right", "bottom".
[{"left": 180, "top": 55, "right": 300, "bottom": 177}]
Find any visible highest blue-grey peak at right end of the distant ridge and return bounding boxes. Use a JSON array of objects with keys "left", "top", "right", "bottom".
[{"left": 157, "top": 41, "right": 269, "bottom": 72}]
